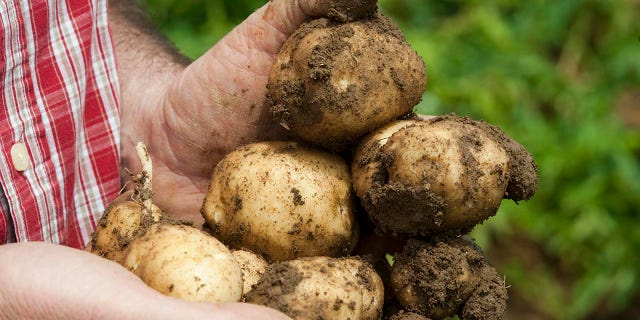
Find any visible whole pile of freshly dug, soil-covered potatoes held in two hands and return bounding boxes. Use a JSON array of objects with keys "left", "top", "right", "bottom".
[{"left": 88, "top": 1, "right": 537, "bottom": 320}]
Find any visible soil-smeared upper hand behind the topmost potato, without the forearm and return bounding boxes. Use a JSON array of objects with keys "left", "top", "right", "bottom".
[{"left": 123, "top": 0, "right": 375, "bottom": 224}]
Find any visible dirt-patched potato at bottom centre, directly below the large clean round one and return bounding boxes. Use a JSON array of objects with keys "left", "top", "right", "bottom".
[{"left": 246, "top": 257, "right": 384, "bottom": 320}]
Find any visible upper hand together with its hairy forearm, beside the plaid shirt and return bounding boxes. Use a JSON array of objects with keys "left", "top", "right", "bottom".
[{"left": 110, "top": 0, "right": 364, "bottom": 225}]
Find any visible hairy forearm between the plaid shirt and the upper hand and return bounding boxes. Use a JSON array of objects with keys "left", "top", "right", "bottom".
[{"left": 108, "top": 0, "right": 190, "bottom": 170}]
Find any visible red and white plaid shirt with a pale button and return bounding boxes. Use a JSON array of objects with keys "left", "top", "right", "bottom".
[{"left": 0, "top": 0, "right": 120, "bottom": 247}]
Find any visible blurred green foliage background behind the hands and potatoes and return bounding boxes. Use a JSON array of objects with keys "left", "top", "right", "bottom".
[{"left": 138, "top": 0, "right": 640, "bottom": 319}]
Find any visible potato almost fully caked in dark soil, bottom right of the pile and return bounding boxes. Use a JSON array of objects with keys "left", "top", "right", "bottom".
[{"left": 391, "top": 237, "right": 507, "bottom": 320}]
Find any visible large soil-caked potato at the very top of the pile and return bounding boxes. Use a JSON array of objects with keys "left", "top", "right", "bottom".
[{"left": 267, "top": 13, "right": 426, "bottom": 150}]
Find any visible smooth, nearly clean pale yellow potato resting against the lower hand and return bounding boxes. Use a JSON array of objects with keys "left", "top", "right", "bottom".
[{"left": 122, "top": 223, "right": 243, "bottom": 303}]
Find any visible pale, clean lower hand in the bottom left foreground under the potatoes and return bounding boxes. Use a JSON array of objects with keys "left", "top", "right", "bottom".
[{"left": 0, "top": 242, "right": 288, "bottom": 320}]
